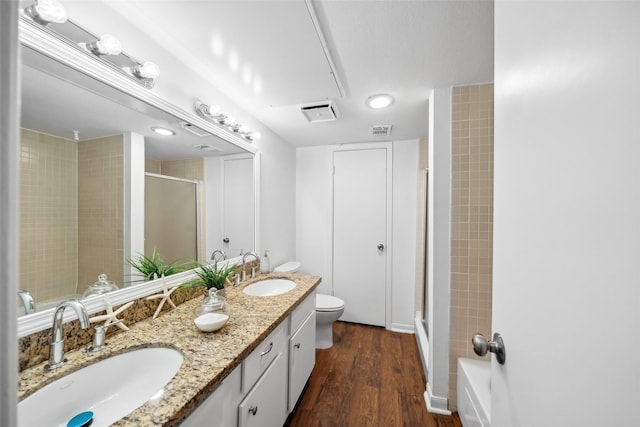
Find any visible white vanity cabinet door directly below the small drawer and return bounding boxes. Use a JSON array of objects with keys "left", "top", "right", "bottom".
[{"left": 238, "top": 353, "right": 287, "bottom": 427}]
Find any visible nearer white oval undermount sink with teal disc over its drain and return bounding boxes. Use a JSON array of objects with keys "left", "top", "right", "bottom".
[{"left": 18, "top": 347, "right": 183, "bottom": 427}]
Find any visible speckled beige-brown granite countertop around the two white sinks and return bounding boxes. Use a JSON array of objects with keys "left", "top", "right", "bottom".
[{"left": 18, "top": 273, "right": 320, "bottom": 427}]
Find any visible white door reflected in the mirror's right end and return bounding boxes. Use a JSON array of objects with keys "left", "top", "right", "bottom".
[{"left": 220, "top": 157, "right": 255, "bottom": 258}]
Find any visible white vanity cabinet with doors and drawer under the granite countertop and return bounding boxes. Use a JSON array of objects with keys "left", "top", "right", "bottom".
[{"left": 181, "top": 292, "right": 316, "bottom": 427}]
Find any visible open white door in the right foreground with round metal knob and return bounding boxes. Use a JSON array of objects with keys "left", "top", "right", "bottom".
[{"left": 491, "top": 2, "right": 640, "bottom": 427}]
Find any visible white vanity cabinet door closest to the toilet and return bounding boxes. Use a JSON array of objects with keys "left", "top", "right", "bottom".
[{"left": 289, "top": 310, "right": 316, "bottom": 412}]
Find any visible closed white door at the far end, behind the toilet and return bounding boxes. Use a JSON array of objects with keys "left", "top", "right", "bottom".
[{"left": 333, "top": 147, "right": 391, "bottom": 326}]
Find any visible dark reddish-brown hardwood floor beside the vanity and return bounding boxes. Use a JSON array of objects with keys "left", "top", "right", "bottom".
[{"left": 285, "top": 322, "right": 462, "bottom": 427}]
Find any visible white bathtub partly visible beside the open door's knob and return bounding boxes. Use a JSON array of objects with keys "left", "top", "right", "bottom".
[{"left": 457, "top": 358, "right": 491, "bottom": 427}]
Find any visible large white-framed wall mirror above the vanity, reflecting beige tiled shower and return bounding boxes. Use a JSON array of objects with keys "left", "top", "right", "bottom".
[{"left": 16, "top": 17, "right": 258, "bottom": 334}]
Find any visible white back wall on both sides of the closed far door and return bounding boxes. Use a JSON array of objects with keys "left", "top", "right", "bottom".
[{"left": 295, "top": 140, "right": 418, "bottom": 331}]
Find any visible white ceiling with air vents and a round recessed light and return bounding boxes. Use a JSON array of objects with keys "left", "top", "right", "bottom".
[{"left": 96, "top": 0, "right": 493, "bottom": 146}]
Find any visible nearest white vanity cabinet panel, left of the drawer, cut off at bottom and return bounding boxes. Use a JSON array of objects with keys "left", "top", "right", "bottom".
[{"left": 180, "top": 366, "right": 242, "bottom": 427}]
